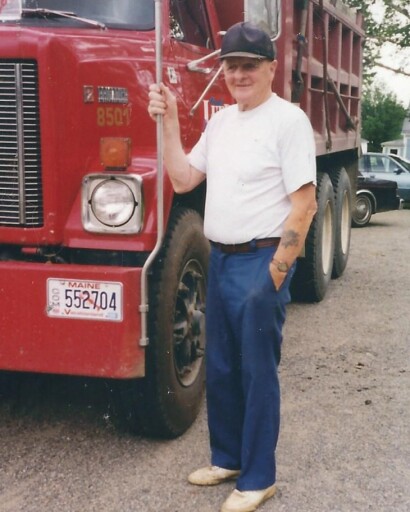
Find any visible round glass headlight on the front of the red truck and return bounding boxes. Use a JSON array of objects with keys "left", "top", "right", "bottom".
[{"left": 90, "top": 179, "right": 136, "bottom": 227}]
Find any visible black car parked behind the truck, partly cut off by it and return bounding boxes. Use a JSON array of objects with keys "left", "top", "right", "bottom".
[{"left": 352, "top": 175, "right": 403, "bottom": 228}]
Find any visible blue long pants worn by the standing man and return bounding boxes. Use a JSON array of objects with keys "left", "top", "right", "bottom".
[{"left": 206, "top": 247, "right": 294, "bottom": 491}]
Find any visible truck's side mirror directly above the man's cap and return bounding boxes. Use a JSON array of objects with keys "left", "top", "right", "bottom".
[{"left": 245, "top": 0, "right": 282, "bottom": 41}]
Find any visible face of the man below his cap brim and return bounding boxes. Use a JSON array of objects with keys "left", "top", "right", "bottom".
[{"left": 223, "top": 57, "right": 277, "bottom": 110}]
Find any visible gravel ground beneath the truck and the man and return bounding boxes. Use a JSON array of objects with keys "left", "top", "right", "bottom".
[{"left": 0, "top": 210, "right": 410, "bottom": 512}]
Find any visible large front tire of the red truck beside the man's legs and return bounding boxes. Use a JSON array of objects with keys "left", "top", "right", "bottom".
[{"left": 119, "top": 208, "right": 209, "bottom": 438}]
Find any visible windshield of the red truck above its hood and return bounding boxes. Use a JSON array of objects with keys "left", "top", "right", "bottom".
[{"left": 22, "top": 0, "right": 155, "bottom": 30}]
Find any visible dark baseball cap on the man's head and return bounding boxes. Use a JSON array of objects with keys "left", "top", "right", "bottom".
[{"left": 220, "top": 21, "right": 275, "bottom": 60}]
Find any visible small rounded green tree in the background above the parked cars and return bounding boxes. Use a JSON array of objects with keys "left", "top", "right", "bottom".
[{"left": 362, "top": 86, "right": 407, "bottom": 152}]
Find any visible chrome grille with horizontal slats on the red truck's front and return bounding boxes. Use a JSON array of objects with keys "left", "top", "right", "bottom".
[{"left": 0, "top": 60, "right": 43, "bottom": 227}]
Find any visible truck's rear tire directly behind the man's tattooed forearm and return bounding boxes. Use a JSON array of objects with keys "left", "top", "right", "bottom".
[{"left": 291, "top": 173, "right": 335, "bottom": 302}]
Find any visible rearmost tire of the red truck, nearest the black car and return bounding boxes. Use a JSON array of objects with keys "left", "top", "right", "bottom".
[{"left": 330, "top": 168, "right": 352, "bottom": 279}]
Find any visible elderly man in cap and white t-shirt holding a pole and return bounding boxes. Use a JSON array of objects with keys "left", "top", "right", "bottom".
[{"left": 148, "top": 23, "right": 316, "bottom": 512}]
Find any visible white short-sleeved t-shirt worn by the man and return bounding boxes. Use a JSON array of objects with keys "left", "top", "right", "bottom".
[{"left": 189, "top": 94, "right": 316, "bottom": 244}]
